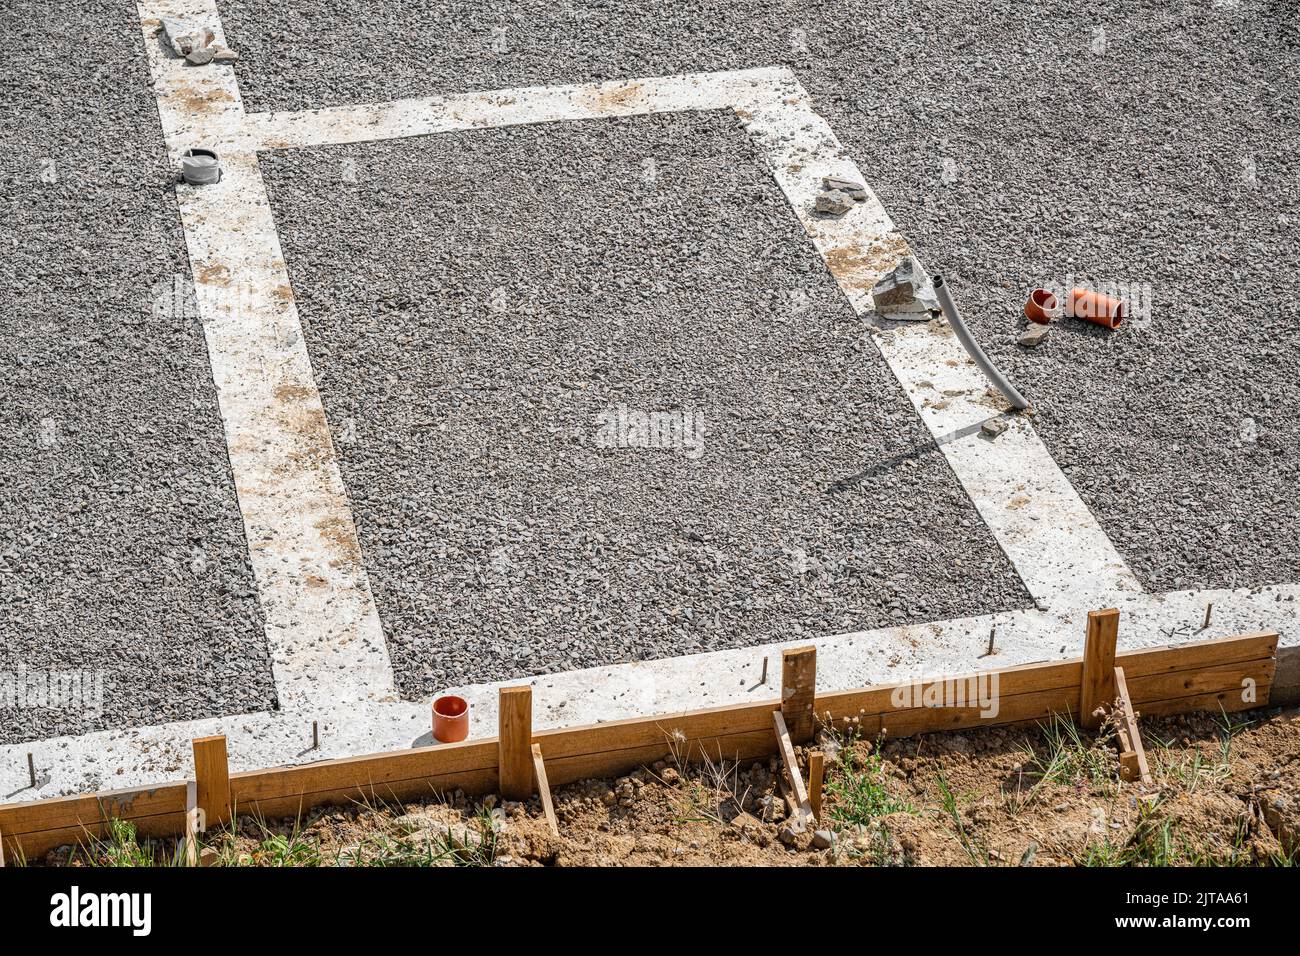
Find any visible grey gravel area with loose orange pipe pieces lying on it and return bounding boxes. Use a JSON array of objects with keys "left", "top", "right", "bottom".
[{"left": 221, "top": 0, "right": 1300, "bottom": 591}]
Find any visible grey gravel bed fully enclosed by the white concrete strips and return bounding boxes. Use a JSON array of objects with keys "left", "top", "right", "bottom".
[{"left": 263, "top": 112, "right": 1030, "bottom": 696}]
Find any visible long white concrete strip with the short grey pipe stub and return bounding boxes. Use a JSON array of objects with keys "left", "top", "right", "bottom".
[{"left": 140, "top": 0, "right": 394, "bottom": 710}]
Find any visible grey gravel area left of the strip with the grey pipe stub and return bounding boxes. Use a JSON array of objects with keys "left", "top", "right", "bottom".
[{"left": 0, "top": 0, "right": 274, "bottom": 743}]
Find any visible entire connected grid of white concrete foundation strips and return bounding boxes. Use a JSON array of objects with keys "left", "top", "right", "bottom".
[{"left": 0, "top": 0, "right": 1300, "bottom": 800}]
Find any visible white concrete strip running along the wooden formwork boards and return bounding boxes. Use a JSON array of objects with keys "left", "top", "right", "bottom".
[{"left": 0, "top": 585, "right": 1300, "bottom": 801}]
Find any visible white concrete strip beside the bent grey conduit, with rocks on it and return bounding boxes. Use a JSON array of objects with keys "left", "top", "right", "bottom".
[{"left": 738, "top": 83, "right": 1141, "bottom": 609}]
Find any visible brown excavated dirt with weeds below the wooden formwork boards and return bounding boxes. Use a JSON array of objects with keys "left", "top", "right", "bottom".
[{"left": 47, "top": 710, "right": 1300, "bottom": 866}]
